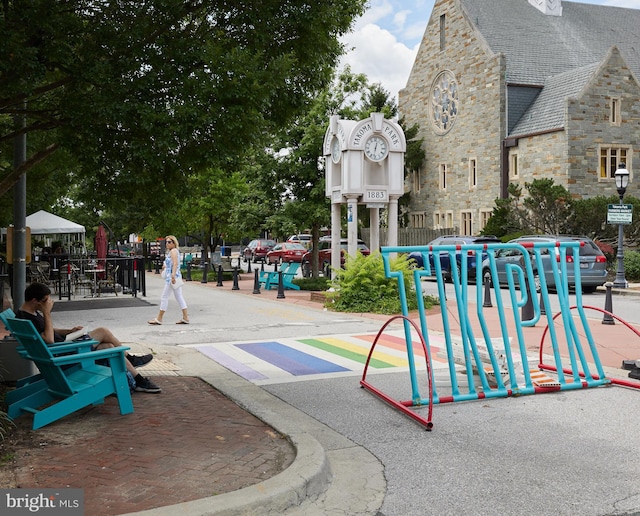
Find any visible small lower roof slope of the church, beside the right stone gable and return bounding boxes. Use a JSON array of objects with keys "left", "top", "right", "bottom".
[{"left": 509, "top": 63, "right": 600, "bottom": 137}]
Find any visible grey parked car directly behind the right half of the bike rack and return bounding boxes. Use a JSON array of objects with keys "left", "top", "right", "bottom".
[{"left": 482, "top": 235, "right": 607, "bottom": 292}]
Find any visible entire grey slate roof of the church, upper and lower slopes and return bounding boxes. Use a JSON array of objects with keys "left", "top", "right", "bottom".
[{"left": 460, "top": 0, "right": 640, "bottom": 137}]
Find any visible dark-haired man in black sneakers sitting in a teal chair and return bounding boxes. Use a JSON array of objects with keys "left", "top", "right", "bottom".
[{"left": 16, "top": 282, "right": 162, "bottom": 393}]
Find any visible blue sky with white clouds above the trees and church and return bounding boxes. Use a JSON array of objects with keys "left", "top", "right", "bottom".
[{"left": 341, "top": 0, "right": 640, "bottom": 100}]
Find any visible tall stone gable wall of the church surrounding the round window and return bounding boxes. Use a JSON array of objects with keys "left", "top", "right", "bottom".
[{"left": 399, "top": 0, "right": 505, "bottom": 234}]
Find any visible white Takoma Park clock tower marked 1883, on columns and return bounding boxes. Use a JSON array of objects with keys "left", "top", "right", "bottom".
[{"left": 323, "top": 113, "right": 407, "bottom": 269}]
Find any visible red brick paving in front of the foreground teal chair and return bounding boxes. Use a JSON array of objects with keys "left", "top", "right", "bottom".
[{"left": 2, "top": 376, "right": 295, "bottom": 516}]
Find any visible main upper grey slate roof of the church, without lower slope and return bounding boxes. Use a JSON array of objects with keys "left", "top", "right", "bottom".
[{"left": 460, "top": 0, "right": 640, "bottom": 86}]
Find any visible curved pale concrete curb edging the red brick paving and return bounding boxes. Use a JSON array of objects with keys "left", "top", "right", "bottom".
[{"left": 124, "top": 346, "right": 386, "bottom": 516}]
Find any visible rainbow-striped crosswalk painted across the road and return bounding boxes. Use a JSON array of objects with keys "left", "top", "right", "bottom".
[{"left": 194, "top": 330, "right": 444, "bottom": 385}]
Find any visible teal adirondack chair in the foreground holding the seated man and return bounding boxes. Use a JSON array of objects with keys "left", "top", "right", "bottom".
[{"left": 6, "top": 318, "right": 133, "bottom": 430}]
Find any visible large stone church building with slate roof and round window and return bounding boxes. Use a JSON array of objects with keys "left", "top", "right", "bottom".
[{"left": 399, "top": 0, "right": 640, "bottom": 235}]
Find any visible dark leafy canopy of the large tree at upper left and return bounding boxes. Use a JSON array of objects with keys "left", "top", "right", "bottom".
[{"left": 0, "top": 0, "right": 366, "bottom": 220}]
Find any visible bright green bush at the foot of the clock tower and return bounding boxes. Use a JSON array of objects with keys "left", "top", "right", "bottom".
[{"left": 325, "top": 253, "right": 438, "bottom": 314}]
